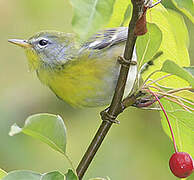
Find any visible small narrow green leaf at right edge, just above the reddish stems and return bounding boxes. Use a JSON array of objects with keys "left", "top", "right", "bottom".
[{"left": 161, "top": 60, "right": 194, "bottom": 88}]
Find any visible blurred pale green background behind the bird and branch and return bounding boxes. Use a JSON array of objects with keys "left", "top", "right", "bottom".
[{"left": 0, "top": 0, "right": 194, "bottom": 180}]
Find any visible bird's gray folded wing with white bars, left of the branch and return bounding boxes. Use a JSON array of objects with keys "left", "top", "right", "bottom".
[{"left": 81, "top": 27, "right": 128, "bottom": 50}]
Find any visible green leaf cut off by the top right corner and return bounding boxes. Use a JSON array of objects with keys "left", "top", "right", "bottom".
[{"left": 172, "top": 0, "right": 194, "bottom": 23}]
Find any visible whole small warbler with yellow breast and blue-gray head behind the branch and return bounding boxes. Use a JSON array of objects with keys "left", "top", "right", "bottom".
[{"left": 8, "top": 27, "right": 137, "bottom": 107}]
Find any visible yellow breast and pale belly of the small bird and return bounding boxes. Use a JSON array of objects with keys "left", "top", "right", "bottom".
[{"left": 38, "top": 57, "right": 118, "bottom": 107}]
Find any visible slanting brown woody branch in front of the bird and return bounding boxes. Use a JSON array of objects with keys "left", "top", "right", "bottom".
[{"left": 76, "top": 0, "right": 144, "bottom": 180}]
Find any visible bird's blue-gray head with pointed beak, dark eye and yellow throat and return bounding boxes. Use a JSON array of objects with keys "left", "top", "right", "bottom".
[{"left": 8, "top": 31, "right": 75, "bottom": 70}]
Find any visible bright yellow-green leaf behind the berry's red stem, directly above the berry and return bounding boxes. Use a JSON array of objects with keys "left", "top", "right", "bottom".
[{"left": 160, "top": 98, "right": 194, "bottom": 160}]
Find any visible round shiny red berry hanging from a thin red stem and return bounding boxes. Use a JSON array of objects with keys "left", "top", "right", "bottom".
[{"left": 169, "top": 152, "right": 194, "bottom": 178}]
